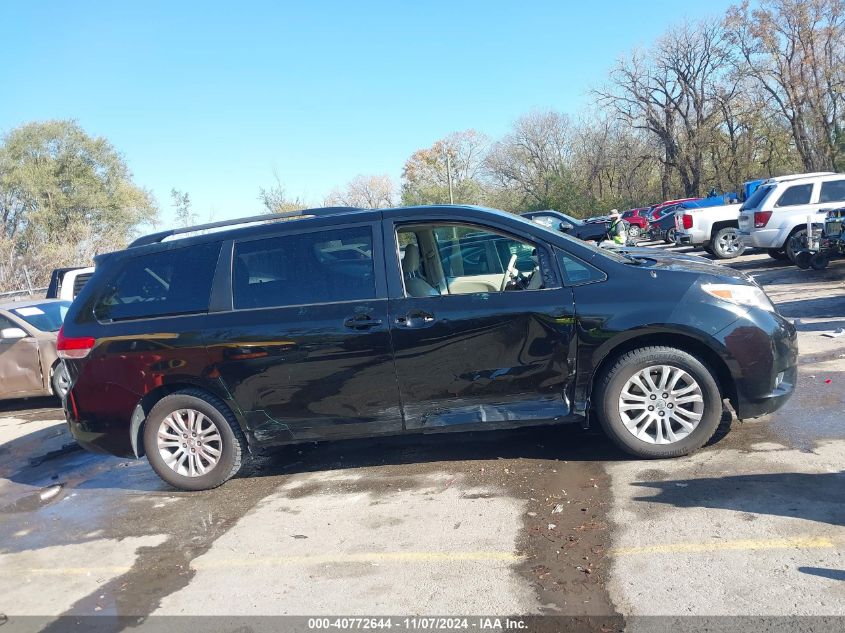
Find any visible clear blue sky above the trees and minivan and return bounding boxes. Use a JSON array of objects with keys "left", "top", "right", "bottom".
[{"left": 0, "top": 0, "right": 732, "bottom": 225}]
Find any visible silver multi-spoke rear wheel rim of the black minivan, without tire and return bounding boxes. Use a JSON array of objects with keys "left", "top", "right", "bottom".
[{"left": 157, "top": 409, "right": 223, "bottom": 477}]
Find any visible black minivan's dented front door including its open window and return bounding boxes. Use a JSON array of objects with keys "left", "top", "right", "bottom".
[{"left": 384, "top": 218, "right": 575, "bottom": 430}]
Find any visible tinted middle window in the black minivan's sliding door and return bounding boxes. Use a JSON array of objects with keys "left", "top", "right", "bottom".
[{"left": 232, "top": 226, "right": 376, "bottom": 309}]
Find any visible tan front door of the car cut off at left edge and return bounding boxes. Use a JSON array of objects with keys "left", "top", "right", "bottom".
[{"left": 0, "top": 317, "right": 44, "bottom": 398}]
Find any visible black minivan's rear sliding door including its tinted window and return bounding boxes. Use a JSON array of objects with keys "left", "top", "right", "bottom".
[{"left": 205, "top": 222, "right": 402, "bottom": 443}]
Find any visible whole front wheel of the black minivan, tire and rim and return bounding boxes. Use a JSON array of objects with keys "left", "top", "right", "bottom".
[{"left": 596, "top": 347, "right": 722, "bottom": 458}]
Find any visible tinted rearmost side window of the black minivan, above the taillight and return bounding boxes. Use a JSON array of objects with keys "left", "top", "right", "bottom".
[{"left": 94, "top": 242, "right": 220, "bottom": 321}]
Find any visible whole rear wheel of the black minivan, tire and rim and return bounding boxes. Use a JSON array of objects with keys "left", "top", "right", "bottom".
[{"left": 144, "top": 389, "right": 247, "bottom": 490}]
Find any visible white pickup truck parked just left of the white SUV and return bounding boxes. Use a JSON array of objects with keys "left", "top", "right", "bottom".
[{"left": 675, "top": 204, "right": 745, "bottom": 259}]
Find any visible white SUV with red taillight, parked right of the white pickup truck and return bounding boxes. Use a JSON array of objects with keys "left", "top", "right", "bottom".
[{"left": 739, "top": 172, "right": 845, "bottom": 261}]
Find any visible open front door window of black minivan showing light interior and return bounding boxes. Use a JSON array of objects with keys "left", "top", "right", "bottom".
[{"left": 397, "top": 224, "right": 554, "bottom": 297}]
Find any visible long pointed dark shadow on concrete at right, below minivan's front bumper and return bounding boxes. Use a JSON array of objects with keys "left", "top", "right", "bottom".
[{"left": 631, "top": 471, "right": 845, "bottom": 526}]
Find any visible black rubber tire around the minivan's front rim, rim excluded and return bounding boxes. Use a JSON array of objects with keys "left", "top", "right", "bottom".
[{"left": 595, "top": 347, "right": 723, "bottom": 459}]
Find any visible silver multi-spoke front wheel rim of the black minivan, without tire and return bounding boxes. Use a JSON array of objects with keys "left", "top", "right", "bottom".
[{"left": 619, "top": 365, "right": 704, "bottom": 444}]
